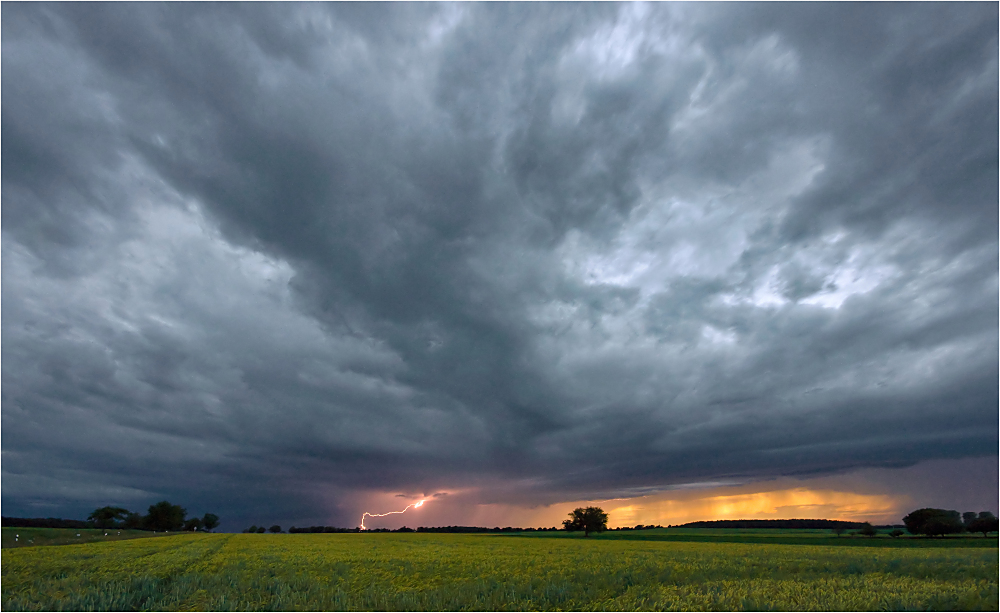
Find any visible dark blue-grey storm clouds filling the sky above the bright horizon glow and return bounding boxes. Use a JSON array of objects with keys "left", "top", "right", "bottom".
[{"left": 2, "top": 2, "right": 1000, "bottom": 530}]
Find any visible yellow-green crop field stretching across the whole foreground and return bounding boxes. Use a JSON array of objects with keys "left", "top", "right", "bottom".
[{"left": 2, "top": 534, "right": 998, "bottom": 611}]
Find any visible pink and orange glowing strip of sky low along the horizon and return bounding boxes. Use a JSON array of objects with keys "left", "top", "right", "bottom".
[{"left": 350, "top": 457, "right": 997, "bottom": 528}]
